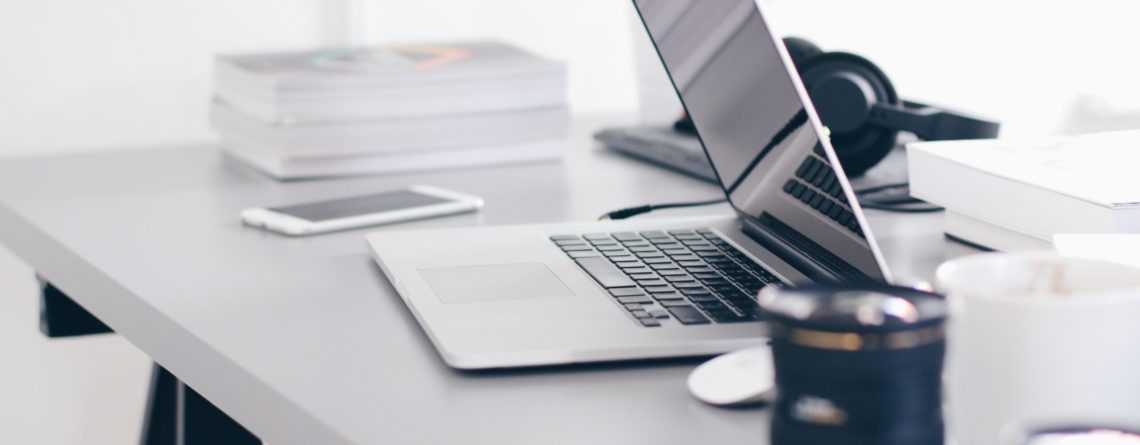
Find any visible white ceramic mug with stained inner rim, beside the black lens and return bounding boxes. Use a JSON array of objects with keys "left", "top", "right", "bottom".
[{"left": 937, "top": 252, "right": 1140, "bottom": 445}]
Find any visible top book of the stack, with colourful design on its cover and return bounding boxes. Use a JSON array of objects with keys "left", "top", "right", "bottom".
[{"left": 214, "top": 42, "right": 567, "bottom": 122}]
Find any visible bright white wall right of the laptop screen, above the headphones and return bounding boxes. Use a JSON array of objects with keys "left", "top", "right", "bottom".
[{"left": 765, "top": 0, "right": 1140, "bottom": 136}]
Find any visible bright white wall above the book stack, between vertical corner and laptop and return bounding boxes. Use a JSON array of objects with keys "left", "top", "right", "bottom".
[{"left": 356, "top": 0, "right": 637, "bottom": 116}]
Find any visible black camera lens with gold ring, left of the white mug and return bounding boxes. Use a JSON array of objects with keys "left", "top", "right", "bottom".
[{"left": 760, "top": 286, "right": 946, "bottom": 445}]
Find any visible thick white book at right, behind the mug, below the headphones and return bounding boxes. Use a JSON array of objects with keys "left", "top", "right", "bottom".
[{"left": 906, "top": 131, "right": 1140, "bottom": 248}]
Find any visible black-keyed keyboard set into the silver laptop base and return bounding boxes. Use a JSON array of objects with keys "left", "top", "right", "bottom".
[{"left": 551, "top": 229, "right": 780, "bottom": 327}]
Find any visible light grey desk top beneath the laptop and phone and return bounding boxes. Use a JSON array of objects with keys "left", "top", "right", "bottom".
[{"left": 0, "top": 119, "right": 971, "bottom": 445}]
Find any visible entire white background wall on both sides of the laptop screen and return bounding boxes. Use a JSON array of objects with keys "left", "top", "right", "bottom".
[{"left": 0, "top": 0, "right": 1140, "bottom": 156}]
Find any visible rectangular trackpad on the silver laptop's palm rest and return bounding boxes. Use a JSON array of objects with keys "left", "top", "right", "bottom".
[{"left": 420, "top": 262, "right": 573, "bottom": 305}]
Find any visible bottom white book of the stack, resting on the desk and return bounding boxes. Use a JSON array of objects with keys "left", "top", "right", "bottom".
[{"left": 222, "top": 134, "right": 567, "bottom": 179}]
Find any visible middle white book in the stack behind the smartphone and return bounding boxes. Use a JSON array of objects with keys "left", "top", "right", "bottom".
[{"left": 210, "top": 100, "right": 570, "bottom": 160}]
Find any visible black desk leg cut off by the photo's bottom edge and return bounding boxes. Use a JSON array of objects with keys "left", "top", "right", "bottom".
[{"left": 141, "top": 363, "right": 261, "bottom": 445}]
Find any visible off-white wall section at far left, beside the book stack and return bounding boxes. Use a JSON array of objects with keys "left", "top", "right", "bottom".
[{"left": 0, "top": 0, "right": 336, "bottom": 155}]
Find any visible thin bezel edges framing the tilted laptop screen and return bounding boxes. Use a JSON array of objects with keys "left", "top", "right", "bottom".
[{"left": 630, "top": 0, "right": 893, "bottom": 283}]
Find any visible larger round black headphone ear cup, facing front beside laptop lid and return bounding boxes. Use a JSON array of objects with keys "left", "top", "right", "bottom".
[{"left": 799, "top": 52, "right": 899, "bottom": 177}]
